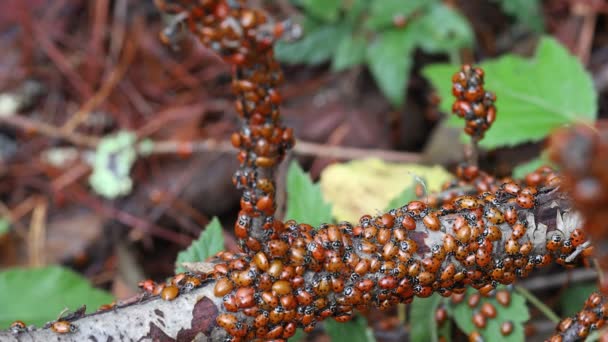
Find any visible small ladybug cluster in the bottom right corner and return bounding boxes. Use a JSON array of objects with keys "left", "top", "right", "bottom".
[{"left": 547, "top": 293, "right": 608, "bottom": 342}]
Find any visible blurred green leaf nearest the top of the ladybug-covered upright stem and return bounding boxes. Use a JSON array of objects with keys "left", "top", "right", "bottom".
[{"left": 274, "top": 19, "right": 350, "bottom": 65}]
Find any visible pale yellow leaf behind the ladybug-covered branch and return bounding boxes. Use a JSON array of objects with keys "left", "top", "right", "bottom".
[{"left": 320, "top": 158, "right": 452, "bottom": 222}]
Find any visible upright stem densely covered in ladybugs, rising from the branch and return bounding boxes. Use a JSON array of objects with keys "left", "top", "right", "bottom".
[{"left": 157, "top": 0, "right": 294, "bottom": 252}]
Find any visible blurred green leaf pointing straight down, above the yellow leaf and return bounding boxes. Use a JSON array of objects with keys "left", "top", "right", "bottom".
[{"left": 367, "top": 27, "right": 415, "bottom": 107}]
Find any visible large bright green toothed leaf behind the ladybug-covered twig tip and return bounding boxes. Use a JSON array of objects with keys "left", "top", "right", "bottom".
[{"left": 423, "top": 37, "right": 597, "bottom": 148}]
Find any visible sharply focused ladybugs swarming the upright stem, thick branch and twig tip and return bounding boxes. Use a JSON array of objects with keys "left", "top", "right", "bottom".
[{"left": 150, "top": 0, "right": 592, "bottom": 341}]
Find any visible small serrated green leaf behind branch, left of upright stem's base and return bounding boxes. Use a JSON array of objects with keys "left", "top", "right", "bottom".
[{"left": 175, "top": 217, "right": 224, "bottom": 273}]
